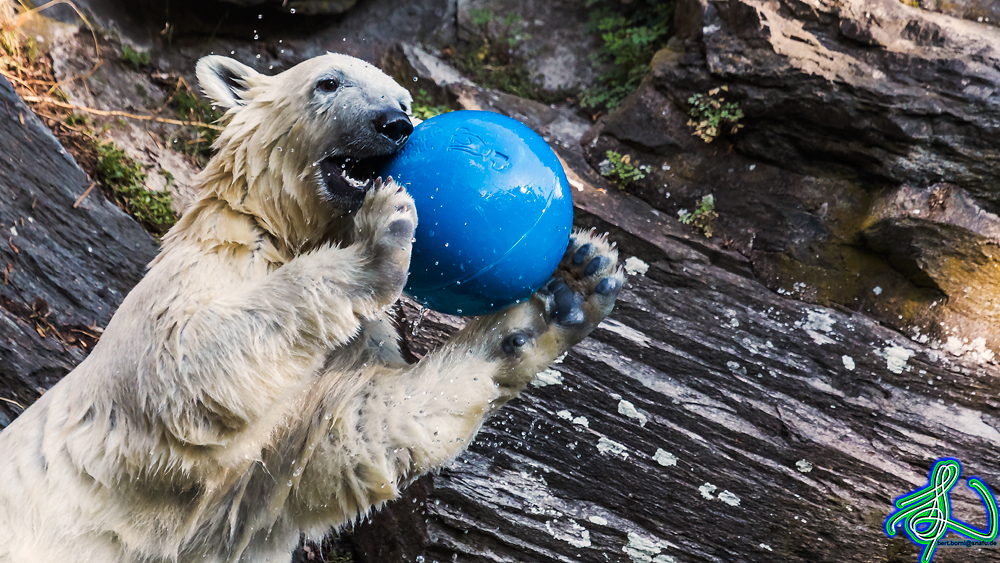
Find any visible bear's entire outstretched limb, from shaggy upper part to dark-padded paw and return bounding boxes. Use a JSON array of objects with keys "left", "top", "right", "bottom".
[{"left": 294, "top": 228, "right": 624, "bottom": 521}]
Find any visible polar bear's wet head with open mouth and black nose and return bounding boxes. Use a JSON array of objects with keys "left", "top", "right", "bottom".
[{"left": 197, "top": 53, "right": 413, "bottom": 248}]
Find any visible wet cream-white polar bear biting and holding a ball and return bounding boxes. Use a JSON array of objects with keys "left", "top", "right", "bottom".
[{"left": 0, "top": 54, "right": 623, "bottom": 563}]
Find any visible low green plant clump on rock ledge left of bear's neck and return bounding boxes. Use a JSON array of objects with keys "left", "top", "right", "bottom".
[{"left": 95, "top": 141, "right": 177, "bottom": 237}]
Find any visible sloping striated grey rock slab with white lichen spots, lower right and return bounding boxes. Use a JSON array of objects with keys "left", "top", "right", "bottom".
[{"left": 354, "top": 159, "right": 1000, "bottom": 562}]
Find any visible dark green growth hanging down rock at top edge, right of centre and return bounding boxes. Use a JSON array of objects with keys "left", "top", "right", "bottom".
[{"left": 580, "top": 0, "right": 676, "bottom": 110}]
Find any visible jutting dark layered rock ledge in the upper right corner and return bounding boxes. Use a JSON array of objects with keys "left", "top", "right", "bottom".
[{"left": 653, "top": 0, "right": 1000, "bottom": 216}]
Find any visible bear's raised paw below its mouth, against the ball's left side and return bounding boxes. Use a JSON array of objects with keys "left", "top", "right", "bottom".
[{"left": 354, "top": 178, "right": 417, "bottom": 304}]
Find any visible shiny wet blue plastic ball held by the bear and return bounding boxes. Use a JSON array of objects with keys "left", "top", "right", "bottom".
[{"left": 380, "top": 111, "right": 573, "bottom": 316}]
